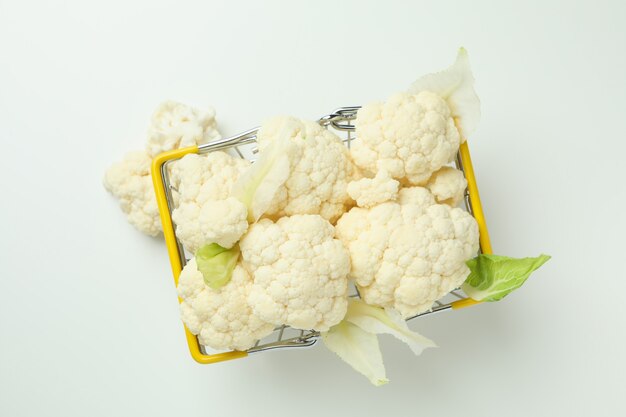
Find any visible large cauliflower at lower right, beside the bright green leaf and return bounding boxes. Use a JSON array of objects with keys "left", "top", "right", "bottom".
[{"left": 336, "top": 187, "right": 478, "bottom": 318}]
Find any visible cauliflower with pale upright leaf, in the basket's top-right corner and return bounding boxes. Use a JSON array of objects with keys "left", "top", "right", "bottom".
[{"left": 352, "top": 48, "right": 480, "bottom": 185}]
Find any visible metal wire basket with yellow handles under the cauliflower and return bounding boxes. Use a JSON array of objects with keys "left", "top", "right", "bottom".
[{"left": 152, "top": 106, "right": 491, "bottom": 364}]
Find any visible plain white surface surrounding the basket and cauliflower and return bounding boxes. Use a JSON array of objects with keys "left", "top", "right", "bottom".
[{"left": 0, "top": 0, "right": 626, "bottom": 417}]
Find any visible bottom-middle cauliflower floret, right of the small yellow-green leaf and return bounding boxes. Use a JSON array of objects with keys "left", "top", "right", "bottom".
[{"left": 239, "top": 215, "right": 350, "bottom": 331}]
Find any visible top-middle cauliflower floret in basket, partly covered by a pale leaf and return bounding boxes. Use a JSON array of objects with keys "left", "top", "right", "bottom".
[{"left": 258, "top": 116, "right": 356, "bottom": 222}]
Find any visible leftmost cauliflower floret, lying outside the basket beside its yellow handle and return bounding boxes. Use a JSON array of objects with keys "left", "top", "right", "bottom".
[{"left": 104, "top": 151, "right": 161, "bottom": 236}]
